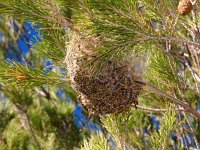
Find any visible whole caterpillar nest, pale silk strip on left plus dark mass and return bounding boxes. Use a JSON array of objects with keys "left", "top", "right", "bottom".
[{"left": 67, "top": 32, "right": 144, "bottom": 115}]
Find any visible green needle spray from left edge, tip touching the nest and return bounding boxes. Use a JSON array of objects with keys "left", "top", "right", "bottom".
[{"left": 0, "top": 60, "right": 65, "bottom": 86}]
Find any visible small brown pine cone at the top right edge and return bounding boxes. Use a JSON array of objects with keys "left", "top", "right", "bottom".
[{"left": 178, "top": 0, "right": 193, "bottom": 16}]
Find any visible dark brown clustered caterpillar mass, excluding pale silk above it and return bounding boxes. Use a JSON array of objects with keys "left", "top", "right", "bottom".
[{"left": 74, "top": 61, "right": 144, "bottom": 114}]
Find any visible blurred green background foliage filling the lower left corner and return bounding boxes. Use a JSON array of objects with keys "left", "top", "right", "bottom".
[{"left": 0, "top": 87, "right": 86, "bottom": 149}]
